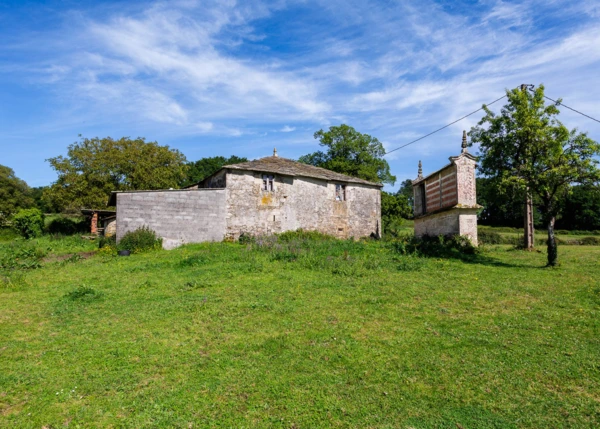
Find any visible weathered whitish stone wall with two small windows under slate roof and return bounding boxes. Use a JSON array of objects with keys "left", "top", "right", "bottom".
[{"left": 227, "top": 171, "right": 381, "bottom": 239}]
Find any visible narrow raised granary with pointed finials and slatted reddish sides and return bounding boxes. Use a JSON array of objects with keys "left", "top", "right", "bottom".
[{"left": 412, "top": 131, "right": 481, "bottom": 245}]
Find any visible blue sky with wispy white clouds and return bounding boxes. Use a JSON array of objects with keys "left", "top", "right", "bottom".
[{"left": 0, "top": 0, "right": 600, "bottom": 189}]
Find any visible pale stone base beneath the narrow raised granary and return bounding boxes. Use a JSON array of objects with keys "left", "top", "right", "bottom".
[{"left": 415, "top": 209, "right": 477, "bottom": 245}]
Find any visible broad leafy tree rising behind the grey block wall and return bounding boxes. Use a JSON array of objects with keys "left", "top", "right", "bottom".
[{"left": 43, "top": 137, "right": 186, "bottom": 211}]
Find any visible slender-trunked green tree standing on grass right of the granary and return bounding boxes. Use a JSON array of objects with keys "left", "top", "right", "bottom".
[{"left": 469, "top": 85, "right": 600, "bottom": 266}]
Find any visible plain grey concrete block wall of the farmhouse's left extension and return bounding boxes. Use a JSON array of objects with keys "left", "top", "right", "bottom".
[{"left": 117, "top": 189, "right": 226, "bottom": 248}]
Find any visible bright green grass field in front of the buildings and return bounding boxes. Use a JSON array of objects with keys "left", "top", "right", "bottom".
[{"left": 0, "top": 232, "right": 600, "bottom": 429}]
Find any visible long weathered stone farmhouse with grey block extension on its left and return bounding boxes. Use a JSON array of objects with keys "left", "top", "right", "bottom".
[{"left": 109, "top": 150, "right": 382, "bottom": 248}]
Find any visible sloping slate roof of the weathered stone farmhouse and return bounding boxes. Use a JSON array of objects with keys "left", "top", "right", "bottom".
[{"left": 223, "top": 155, "right": 383, "bottom": 187}]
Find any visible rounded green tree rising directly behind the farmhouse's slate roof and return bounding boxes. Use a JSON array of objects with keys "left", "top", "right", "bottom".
[{"left": 299, "top": 124, "right": 396, "bottom": 185}]
